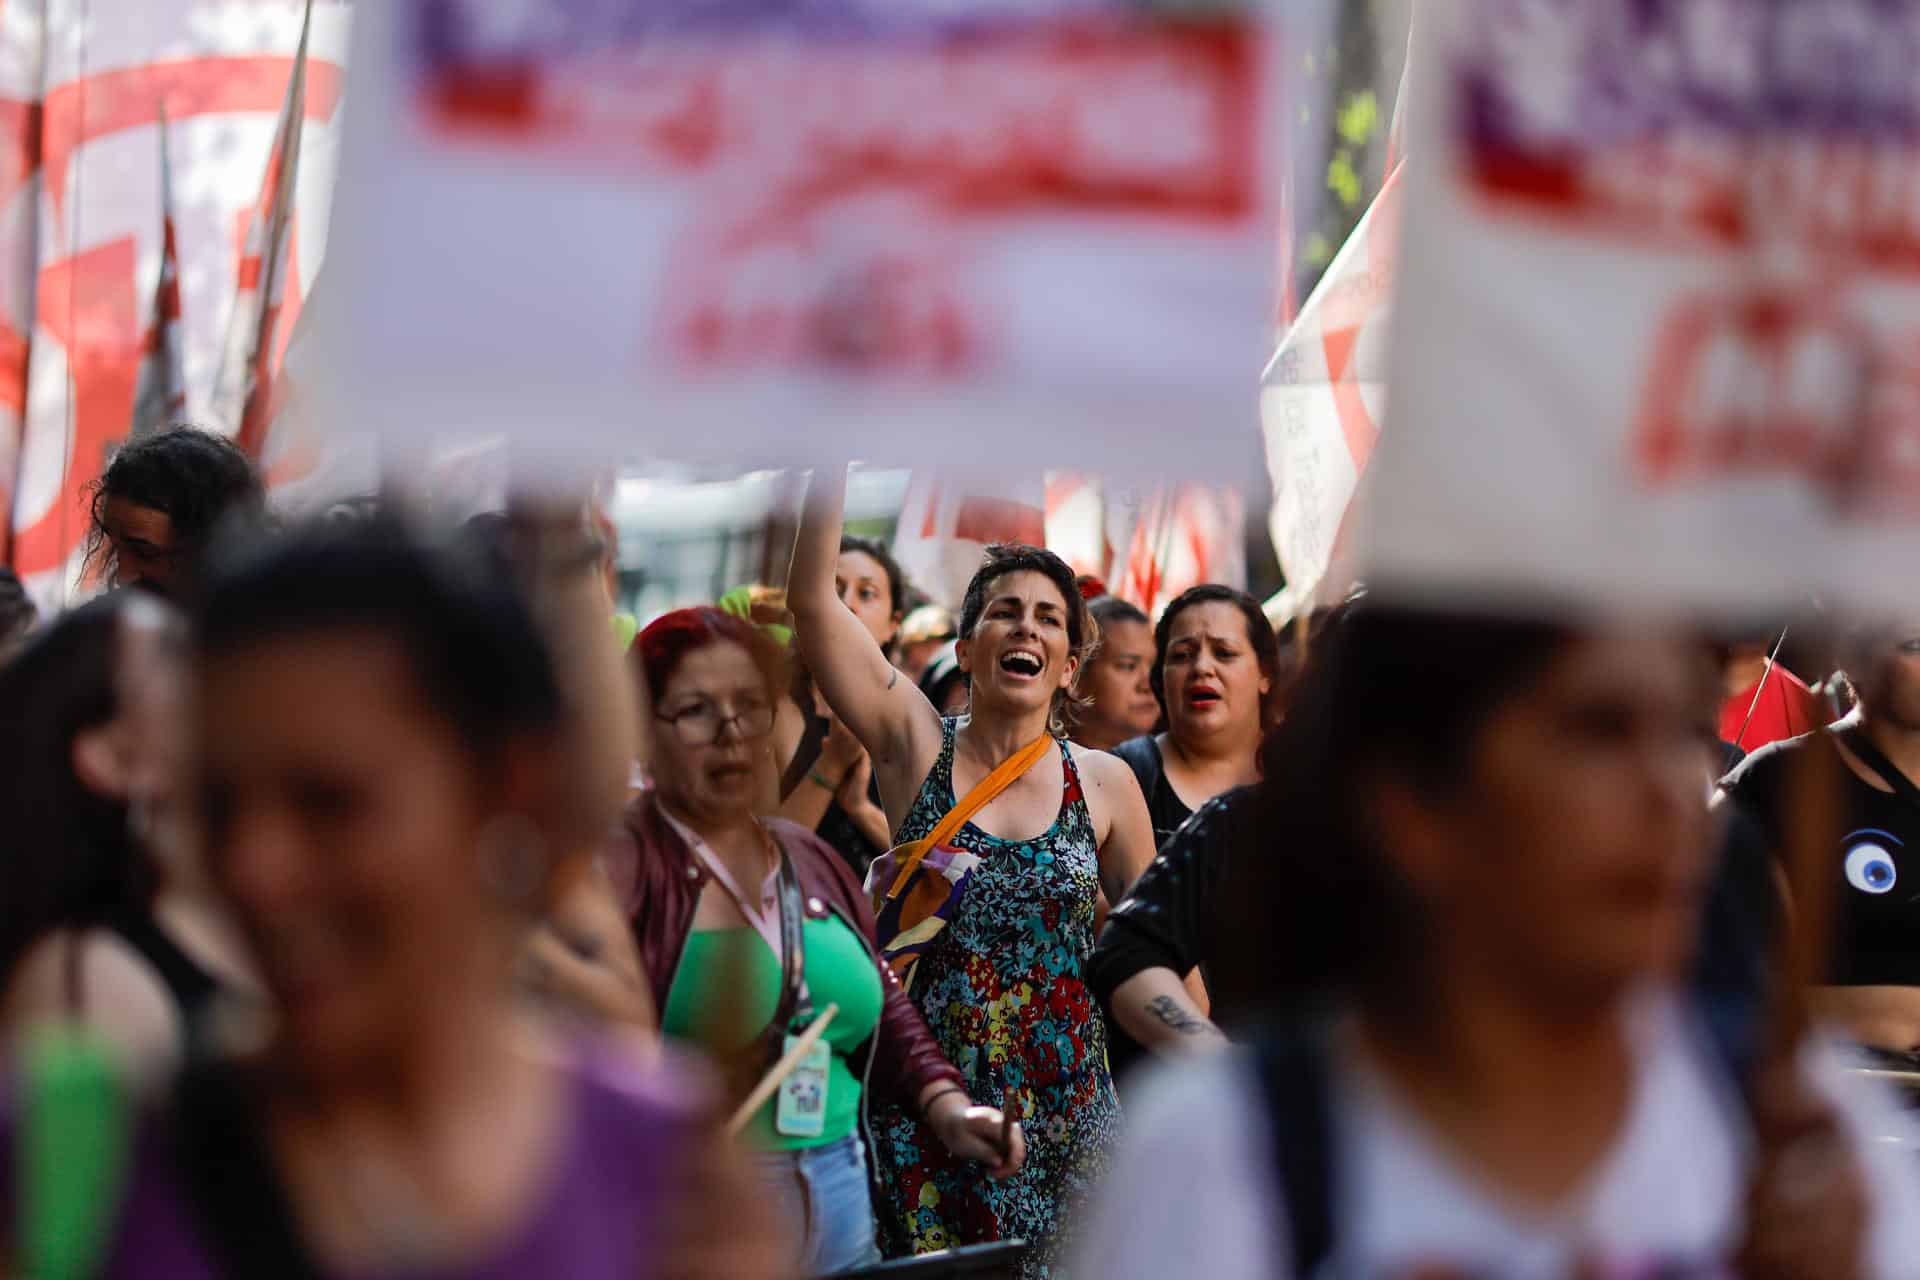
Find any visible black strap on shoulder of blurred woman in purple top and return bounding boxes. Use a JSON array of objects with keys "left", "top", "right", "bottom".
[{"left": 173, "top": 1059, "right": 321, "bottom": 1280}]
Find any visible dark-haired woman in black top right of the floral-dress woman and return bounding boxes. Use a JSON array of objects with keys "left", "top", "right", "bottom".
[{"left": 1114, "top": 583, "right": 1279, "bottom": 844}]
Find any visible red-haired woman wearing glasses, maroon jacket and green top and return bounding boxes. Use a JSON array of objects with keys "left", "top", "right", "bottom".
[{"left": 626, "top": 608, "right": 1023, "bottom": 1274}]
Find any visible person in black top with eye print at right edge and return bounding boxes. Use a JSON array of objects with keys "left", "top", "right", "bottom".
[{"left": 1720, "top": 626, "right": 1920, "bottom": 1055}]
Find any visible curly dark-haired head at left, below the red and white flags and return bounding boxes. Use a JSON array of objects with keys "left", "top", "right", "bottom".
[{"left": 86, "top": 426, "right": 267, "bottom": 599}]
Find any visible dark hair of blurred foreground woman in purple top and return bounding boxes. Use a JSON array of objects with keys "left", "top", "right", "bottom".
[{"left": 198, "top": 514, "right": 564, "bottom": 760}]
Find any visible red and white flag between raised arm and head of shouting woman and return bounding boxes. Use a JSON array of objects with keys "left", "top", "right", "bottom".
[{"left": 893, "top": 470, "right": 1046, "bottom": 608}]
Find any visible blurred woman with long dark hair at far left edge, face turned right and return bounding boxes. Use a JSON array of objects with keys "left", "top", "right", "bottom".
[{"left": 0, "top": 593, "right": 246, "bottom": 1067}]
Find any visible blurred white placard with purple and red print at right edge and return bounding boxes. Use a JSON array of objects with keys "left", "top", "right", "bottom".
[{"left": 1369, "top": 0, "right": 1920, "bottom": 621}]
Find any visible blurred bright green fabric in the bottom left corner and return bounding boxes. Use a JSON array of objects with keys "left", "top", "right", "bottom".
[{"left": 13, "top": 1029, "right": 132, "bottom": 1280}]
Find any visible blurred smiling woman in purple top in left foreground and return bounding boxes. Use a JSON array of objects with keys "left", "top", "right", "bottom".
[{"left": 0, "top": 520, "right": 766, "bottom": 1280}]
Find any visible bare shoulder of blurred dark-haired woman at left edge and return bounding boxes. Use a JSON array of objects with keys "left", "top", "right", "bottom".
[{"left": 0, "top": 929, "right": 184, "bottom": 1075}]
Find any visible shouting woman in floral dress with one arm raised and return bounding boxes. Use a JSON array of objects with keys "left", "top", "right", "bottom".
[{"left": 787, "top": 468, "right": 1154, "bottom": 1276}]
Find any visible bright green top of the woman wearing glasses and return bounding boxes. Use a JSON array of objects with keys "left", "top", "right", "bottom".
[{"left": 660, "top": 915, "right": 881, "bottom": 1151}]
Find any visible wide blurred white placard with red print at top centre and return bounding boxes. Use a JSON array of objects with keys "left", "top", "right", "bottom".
[{"left": 314, "top": 0, "right": 1329, "bottom": 485}]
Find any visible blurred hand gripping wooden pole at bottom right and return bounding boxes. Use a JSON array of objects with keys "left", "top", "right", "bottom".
[{"left": 1738, "top": 1057, "right": 1868, "bottom": 1280}]
